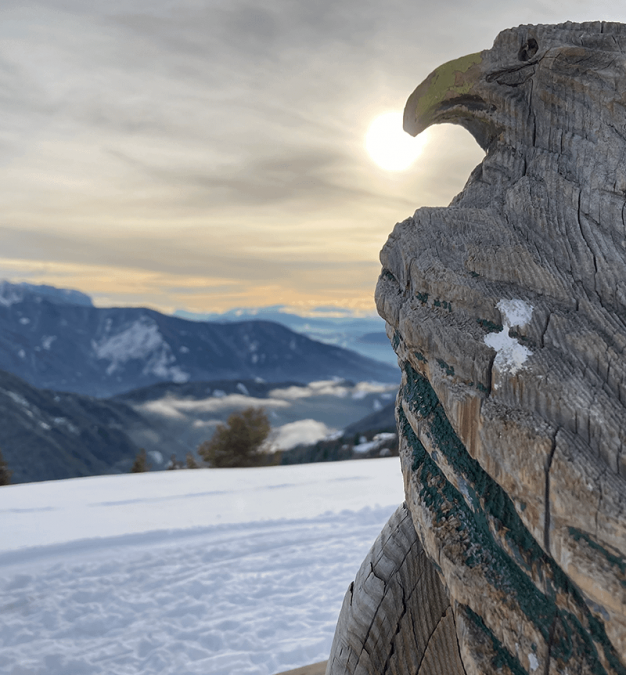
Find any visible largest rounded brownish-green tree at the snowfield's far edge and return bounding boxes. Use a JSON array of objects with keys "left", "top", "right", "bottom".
[{"left": 198, "top": 408, "right": 271, "bottom": 468}]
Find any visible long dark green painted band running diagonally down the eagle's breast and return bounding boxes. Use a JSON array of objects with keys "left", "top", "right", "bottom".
[{"left": 398, "top": 364, "right": 626, "bottom": 675}]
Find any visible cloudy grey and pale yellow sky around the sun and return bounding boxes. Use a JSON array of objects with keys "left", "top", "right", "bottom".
[{"left": 0, "top": 0, "right": 626, "bottom": 313}]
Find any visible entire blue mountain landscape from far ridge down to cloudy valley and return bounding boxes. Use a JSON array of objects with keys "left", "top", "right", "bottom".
[{"left": 0, "top": 282, "right": 399, "bottom": 482}]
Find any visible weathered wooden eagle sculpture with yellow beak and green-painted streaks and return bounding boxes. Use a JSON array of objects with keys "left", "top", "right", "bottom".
[{"left": 327, "top": 22, "right": 626, "bottom": 675}]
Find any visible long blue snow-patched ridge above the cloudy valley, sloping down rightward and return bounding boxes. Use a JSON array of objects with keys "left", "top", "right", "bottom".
[{"left": 0, "top": 282, "right": 400, "bottom": 397}]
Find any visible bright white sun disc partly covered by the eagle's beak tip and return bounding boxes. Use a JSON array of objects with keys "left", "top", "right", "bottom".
[{"left": 365, "top": 112, "right": 426, "bottom": 171}]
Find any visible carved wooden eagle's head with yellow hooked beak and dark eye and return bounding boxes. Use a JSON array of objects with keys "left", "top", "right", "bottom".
[{"left": 404, "top": 22, "right": 626, "bottom": 156}]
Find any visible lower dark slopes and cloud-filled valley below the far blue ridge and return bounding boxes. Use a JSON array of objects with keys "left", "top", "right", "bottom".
[{"left": 0, "top": 370, "right": 396, "bottom": 483}]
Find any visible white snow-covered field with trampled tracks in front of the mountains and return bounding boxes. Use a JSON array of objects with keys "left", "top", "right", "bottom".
[{"left": 0, "top": 457, "right": 404, "bottom": 675}]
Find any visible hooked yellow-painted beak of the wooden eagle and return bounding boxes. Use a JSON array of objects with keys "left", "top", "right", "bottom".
[{"left": 403, "top": 52, "right": 483, "bottom": 136}]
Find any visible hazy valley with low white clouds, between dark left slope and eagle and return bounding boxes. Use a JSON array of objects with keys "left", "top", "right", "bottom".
[{"left": 110, "top": 380, "right": 397, "bottom": 470}]
